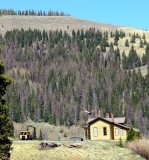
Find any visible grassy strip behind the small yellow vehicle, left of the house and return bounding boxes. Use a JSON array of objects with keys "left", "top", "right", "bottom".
[{"left": 14, "top": 120, "right": 84, "bottom": 141}]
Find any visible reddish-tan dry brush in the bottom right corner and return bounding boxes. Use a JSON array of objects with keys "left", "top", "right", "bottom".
[{"left": 126, "top": 140, "right": 149, "bottom": 160}]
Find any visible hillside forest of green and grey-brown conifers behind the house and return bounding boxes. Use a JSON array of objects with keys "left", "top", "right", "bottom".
[{"left": 0, "top": 28, "right": 149, "bottom": 135}]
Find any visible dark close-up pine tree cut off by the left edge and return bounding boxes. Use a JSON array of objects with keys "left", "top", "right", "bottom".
[{"left": 0, "top": 61, "right": 12, "bottom": 160}]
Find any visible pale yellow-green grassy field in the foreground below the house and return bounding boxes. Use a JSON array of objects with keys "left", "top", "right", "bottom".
[{"left": 11, "top": 141, "right": 143, "bottom": 160}]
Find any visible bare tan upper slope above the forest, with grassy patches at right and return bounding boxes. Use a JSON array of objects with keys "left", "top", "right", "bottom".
[{"left": 0, "top": 15, "right": 149, "bottom": 60}]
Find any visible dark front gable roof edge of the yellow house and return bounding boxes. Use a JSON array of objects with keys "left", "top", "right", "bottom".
[{"left": 88, "top": 117, "right": 130, "bottom": 129}]
